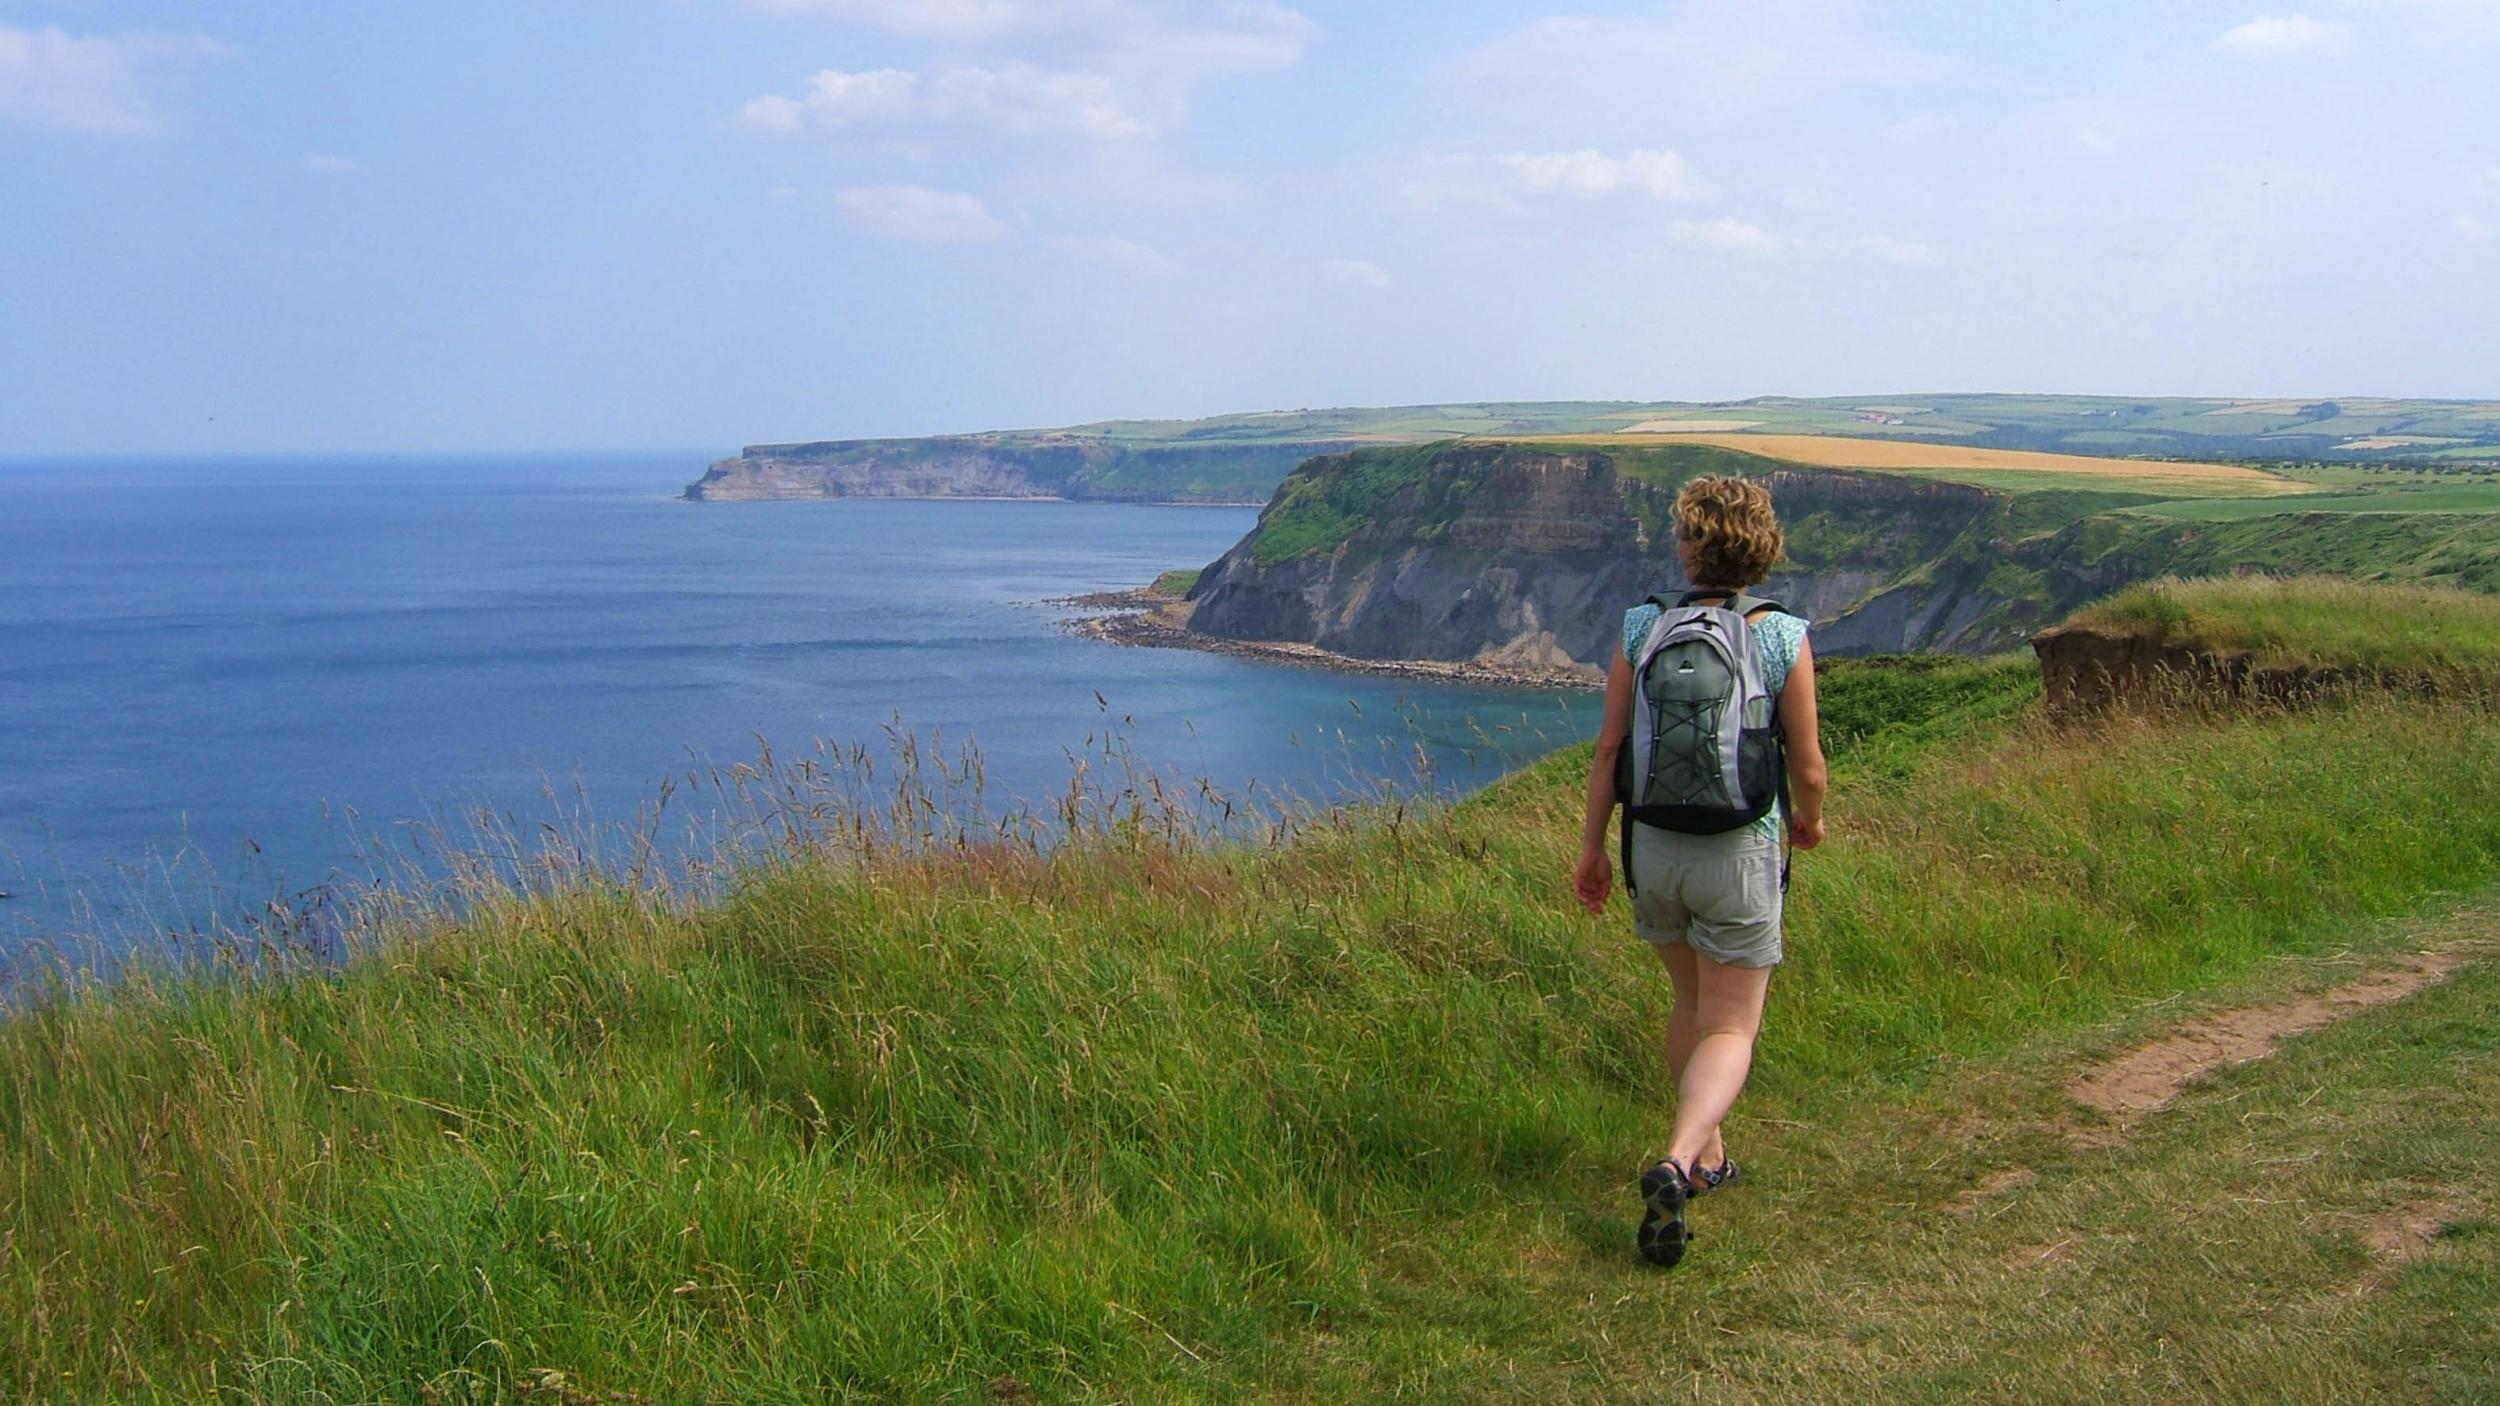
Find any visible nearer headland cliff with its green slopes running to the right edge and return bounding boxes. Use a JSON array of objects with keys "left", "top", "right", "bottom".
[{"left": 1185, "top": 443, "right": 2500, "bottom": 673}]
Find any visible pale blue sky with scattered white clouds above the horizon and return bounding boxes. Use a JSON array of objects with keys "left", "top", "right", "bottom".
[{"left": 0, "top": 0, "right": 2500, "bottom": 453}]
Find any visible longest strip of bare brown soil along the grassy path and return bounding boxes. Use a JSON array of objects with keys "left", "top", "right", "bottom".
[{"left": 2068, "top": 946, "right": 2483, "bottom": 1121}]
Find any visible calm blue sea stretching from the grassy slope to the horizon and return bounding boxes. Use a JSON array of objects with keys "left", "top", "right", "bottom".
[{"left": 0, "top": 453, "right": 1595, "bottom": 966}]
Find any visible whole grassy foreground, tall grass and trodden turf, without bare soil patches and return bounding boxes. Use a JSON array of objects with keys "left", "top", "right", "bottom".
[{"left": 0, "top": 615, "right": 2500, "bottom": 1406}]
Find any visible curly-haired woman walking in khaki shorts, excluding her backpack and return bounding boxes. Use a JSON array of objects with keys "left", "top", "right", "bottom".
[{"left": 1573, "top": 475, "right": 1825, "bottom": 1266}]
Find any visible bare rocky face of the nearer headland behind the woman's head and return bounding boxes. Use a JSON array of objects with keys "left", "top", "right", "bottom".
[{"left": 1190, "top": 445, "right": 2110, "bottom": 668}]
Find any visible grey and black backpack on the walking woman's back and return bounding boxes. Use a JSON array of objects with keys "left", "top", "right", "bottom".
[{"left": 1615, "top": 590, "right": 1788, "bottom": 891}]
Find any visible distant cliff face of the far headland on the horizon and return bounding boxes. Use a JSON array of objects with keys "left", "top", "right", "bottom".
[{"left": 685, "top": 433, "right": 1345, "bottom": 503}]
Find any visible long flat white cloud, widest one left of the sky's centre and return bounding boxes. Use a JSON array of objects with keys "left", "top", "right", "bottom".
[{"left": 738, "top": 63, "right": 1153, "bottom": 140}]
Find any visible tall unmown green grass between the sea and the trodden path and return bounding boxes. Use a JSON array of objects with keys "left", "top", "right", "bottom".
[{"left": 0, "top": 665, "right": 2500, "bottom": 1401}]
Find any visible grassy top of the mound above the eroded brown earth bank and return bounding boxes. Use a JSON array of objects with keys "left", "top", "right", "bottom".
[{"left": 2070, "top": 575, "right": 2500, "bottom": 673}]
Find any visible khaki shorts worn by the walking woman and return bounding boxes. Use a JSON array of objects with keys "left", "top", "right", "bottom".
[{"left": 1630, "top": 826, "right": 1780, "bottom": 966}]
